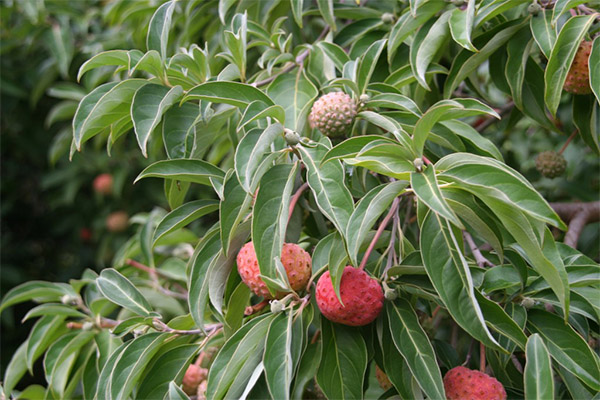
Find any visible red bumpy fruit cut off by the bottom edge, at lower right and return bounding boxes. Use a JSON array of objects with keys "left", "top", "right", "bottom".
[{"left": 444, "top": 367, "right": 506, "bottom": 400}]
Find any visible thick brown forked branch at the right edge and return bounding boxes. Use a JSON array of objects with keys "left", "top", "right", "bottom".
[{"left": 550, "top": 201, "right": 600, "bottom": 248}]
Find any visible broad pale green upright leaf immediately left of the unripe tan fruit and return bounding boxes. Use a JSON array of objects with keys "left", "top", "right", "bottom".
[{"left": 267, "top": 69, "right": 319, "bottom": 132}]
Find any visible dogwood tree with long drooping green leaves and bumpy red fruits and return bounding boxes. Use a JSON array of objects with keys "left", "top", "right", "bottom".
[{"left": 0, "top": 0, "right": 600, "bottom": 399}]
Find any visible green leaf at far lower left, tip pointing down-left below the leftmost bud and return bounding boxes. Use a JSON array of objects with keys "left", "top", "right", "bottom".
[{"left": 25, "top": 315, "right": 65, "bottom": 373}]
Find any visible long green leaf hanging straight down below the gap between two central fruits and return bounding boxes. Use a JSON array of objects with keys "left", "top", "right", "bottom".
[{"left": 263, "top": 310, "right": 304, "bottom": 400}]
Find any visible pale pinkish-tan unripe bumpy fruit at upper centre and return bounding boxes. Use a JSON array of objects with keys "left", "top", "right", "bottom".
[{"left": 308, "top": 92, "right": 356, "bottom": 137}]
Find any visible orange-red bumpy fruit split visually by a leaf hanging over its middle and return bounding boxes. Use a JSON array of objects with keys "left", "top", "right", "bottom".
[{"left": 237, "top": 242, "right": 312, "bottom": 299}]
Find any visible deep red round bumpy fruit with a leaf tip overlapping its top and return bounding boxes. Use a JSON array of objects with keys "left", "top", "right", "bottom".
[{"left": 316, "top": 265, "right": 383, "bottom": 326}]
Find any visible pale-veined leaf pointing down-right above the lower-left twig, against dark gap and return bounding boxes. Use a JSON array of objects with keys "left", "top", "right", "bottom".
[{"left": 96, "top": 268, "right": 152, "bottom": 316}]
